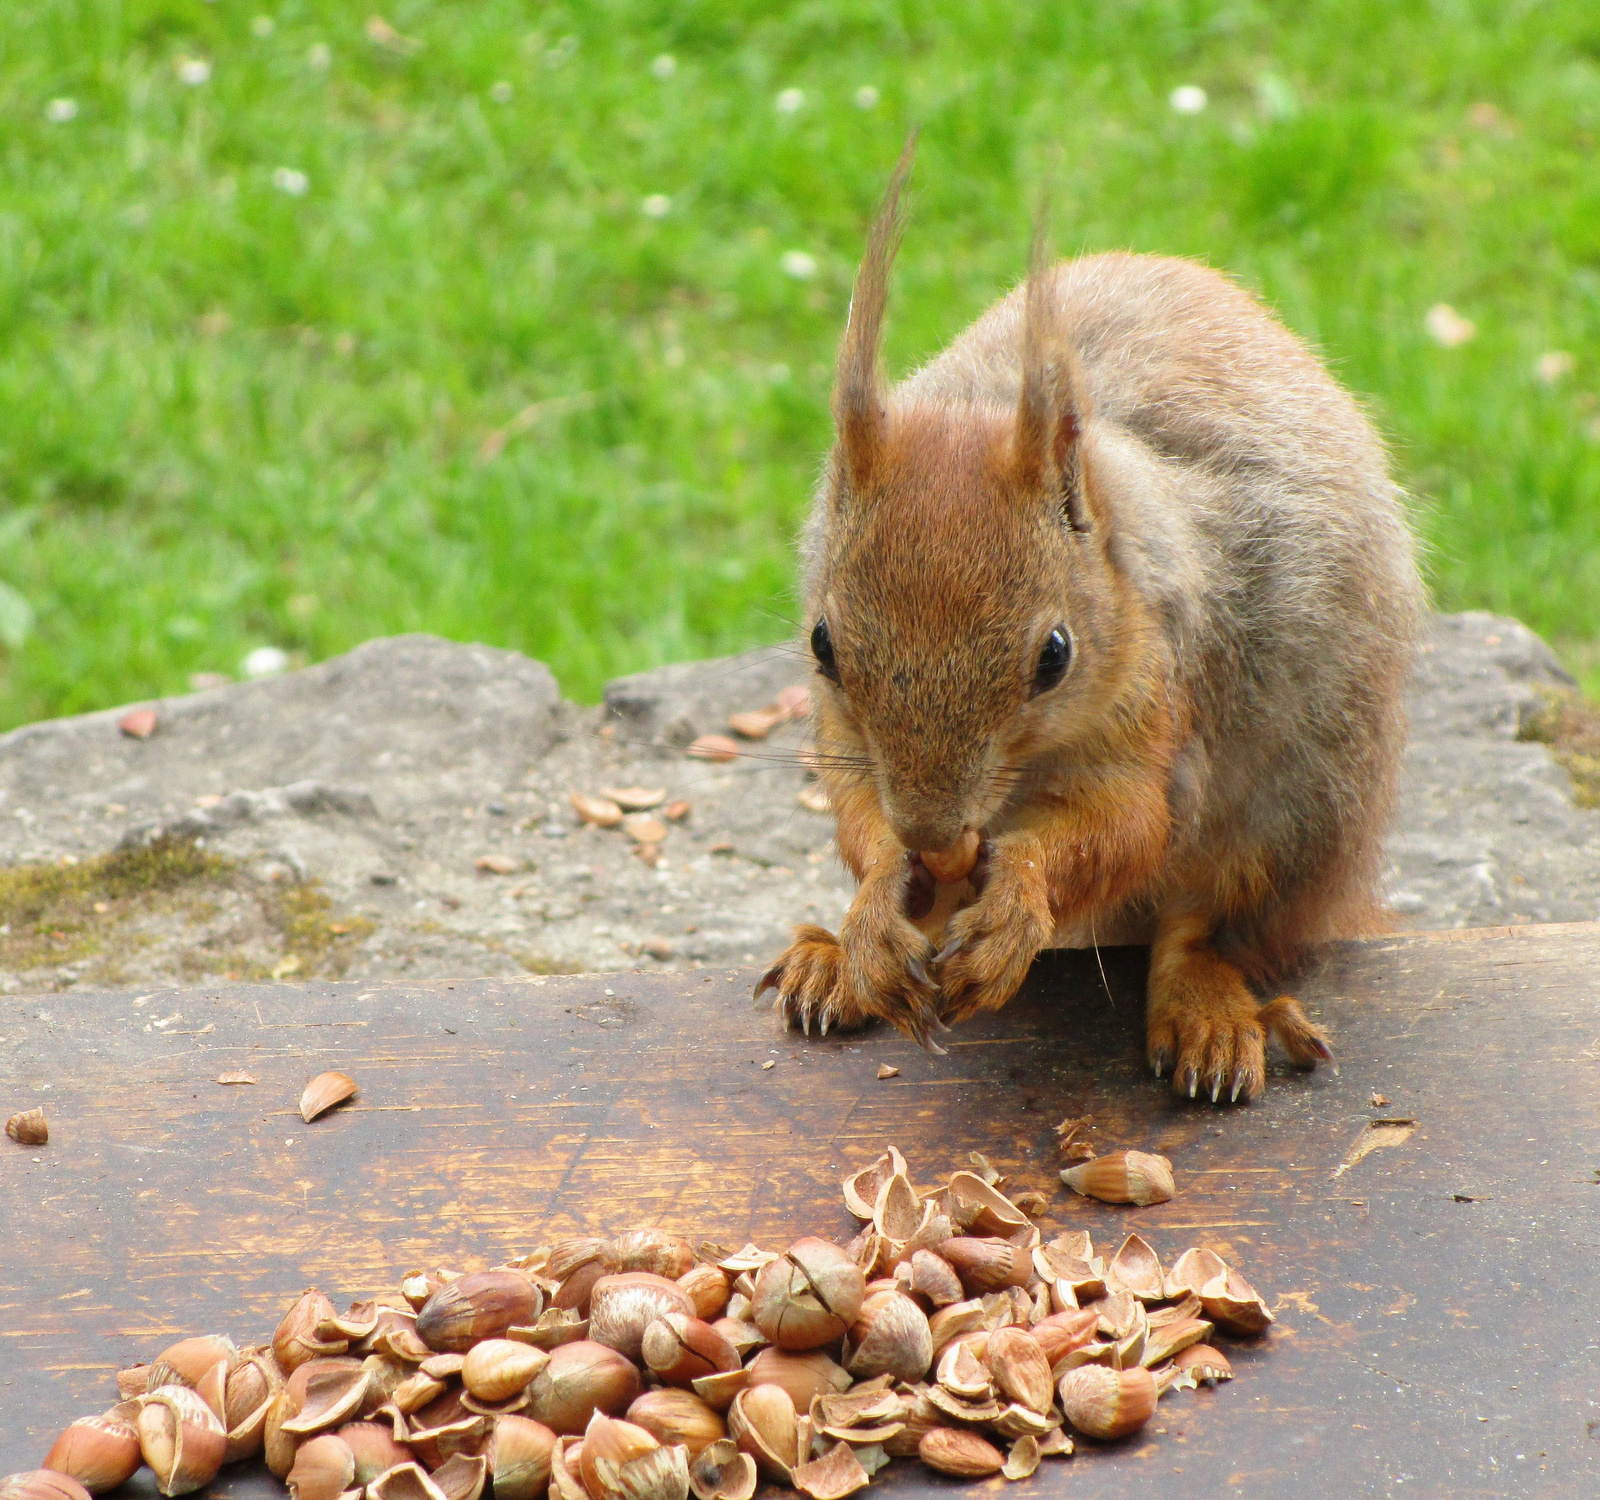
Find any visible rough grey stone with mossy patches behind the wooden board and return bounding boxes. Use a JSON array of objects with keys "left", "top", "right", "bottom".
[{"left": 0, "top": 614, "right": 1600, "bottom": 991}]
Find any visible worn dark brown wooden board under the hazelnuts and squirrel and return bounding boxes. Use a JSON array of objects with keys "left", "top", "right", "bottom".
[{"left": 0, "top": 926, "right": 1600, "bottom": 1497}]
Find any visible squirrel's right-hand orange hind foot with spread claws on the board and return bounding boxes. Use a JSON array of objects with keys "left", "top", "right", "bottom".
[{"left": 1146, "top": 915, "right": 1333, "bottom": 1103}]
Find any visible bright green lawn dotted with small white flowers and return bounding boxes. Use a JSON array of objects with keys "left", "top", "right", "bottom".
[{"left": 0, "top": 0, "right": 1600, "bottom": 726}]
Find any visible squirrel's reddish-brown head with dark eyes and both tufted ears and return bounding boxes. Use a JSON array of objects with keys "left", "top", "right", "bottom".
[{"left": 805, "top": 146, "right": 1125, "bottom": 851}]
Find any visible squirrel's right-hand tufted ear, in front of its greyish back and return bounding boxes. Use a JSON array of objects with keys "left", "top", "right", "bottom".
[{"left": 1016, "top": 203, "right": 1090, "bottom": 531}]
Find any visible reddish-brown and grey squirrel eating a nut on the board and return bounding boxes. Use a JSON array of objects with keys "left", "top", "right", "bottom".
[{"left": 755, "top": 141, "right": 1424, "bottom": 1103}]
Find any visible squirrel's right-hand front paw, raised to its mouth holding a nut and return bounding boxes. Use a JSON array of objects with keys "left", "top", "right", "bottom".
[{"left": 934, "top": 849, "right": 1054, "bottom": 1022}]
